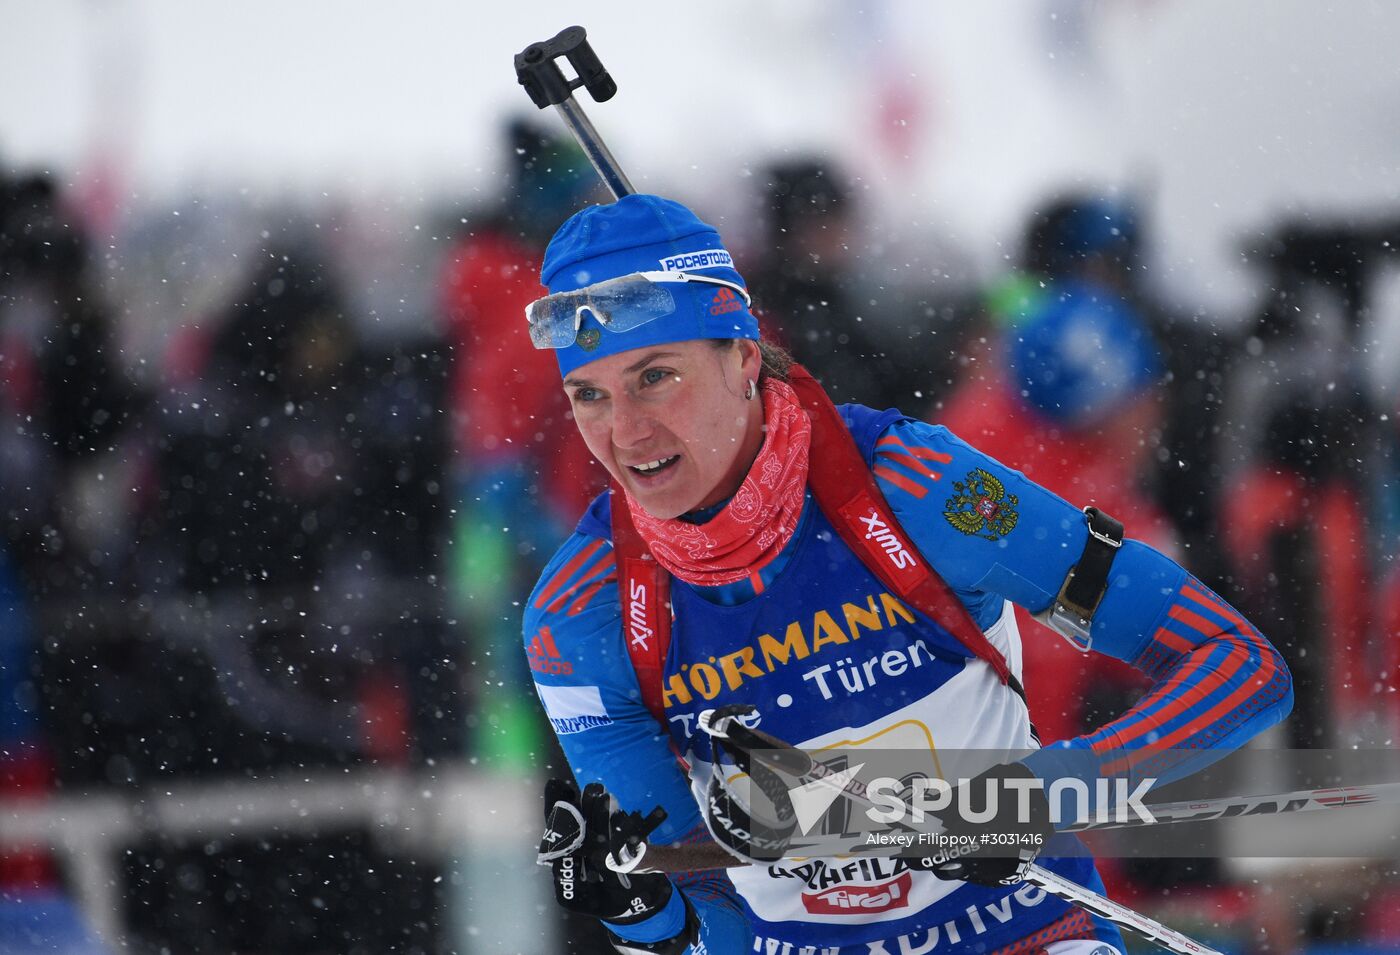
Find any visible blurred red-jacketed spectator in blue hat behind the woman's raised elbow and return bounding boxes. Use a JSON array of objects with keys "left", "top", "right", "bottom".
[{"left": 932, "top": 194, "right": 1179, "bottom": 742}]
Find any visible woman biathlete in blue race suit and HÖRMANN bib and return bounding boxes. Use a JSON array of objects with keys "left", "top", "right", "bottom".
[{"left": 525, "top": 195, "right": 1292, "bottom": 955}]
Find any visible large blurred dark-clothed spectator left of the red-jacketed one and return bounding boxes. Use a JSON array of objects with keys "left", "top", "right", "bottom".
[{"left": 129, "top": 242, "right": 456, "bottom": 766}]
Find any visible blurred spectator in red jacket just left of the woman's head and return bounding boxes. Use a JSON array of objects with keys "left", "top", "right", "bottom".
[{"left": 440, "top": 120, "right": 605, "bottom": 758}]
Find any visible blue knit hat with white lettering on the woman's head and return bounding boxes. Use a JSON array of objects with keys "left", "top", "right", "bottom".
[{"left": 540, "top": 195, "right": 759, "bottom": 375}]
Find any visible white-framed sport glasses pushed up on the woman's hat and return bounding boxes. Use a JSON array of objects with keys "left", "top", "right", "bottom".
[{"left": 525, "top": 272, "right": 753, "bottom": 349}]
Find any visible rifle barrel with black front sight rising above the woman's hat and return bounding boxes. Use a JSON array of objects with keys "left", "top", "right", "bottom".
[{"left": 515, "top": 27, "right": 636, "bottom": 199}]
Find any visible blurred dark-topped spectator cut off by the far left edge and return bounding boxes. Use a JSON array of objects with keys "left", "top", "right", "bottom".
[{"left": 0, "top": 165, "right": 134, "bottom": 952}]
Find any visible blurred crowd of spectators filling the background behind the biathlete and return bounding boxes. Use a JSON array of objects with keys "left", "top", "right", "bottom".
[{"left": 0, "top": 3, "right": 1400, "bottom": 955}]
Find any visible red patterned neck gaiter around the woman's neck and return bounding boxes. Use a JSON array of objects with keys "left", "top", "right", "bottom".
[{"left": 627, "top": 378, "right": 812, "bottom": 587}]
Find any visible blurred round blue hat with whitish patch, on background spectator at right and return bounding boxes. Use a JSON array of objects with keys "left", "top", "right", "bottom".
[{"left": 1007, "top": 283, "right": 1162, "bottom": 427}]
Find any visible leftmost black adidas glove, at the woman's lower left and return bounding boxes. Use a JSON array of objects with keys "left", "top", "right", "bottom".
[{"left": 538, "top": 779, "right": 699, "bottom": 952}]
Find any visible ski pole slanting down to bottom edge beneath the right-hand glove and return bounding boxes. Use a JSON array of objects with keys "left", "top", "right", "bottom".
[{"left": 697, "top": 710, "right": 1221, "bottom": 955}]
